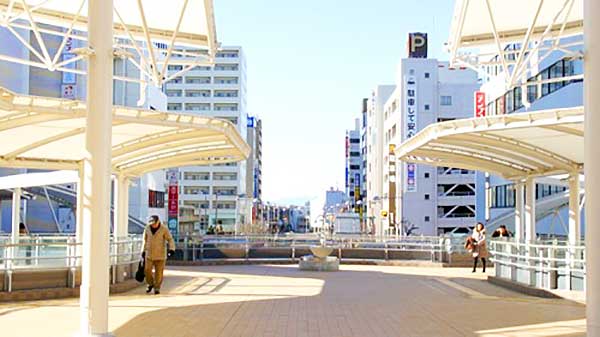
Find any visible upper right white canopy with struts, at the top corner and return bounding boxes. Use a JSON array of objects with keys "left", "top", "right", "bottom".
[{"left": 447, "top": 0, "right": 583, "bottom": 89}]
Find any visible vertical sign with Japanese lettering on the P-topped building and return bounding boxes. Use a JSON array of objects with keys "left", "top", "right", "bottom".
[{"left": 404, "top": 76, "right": 418, "bottom": 192}]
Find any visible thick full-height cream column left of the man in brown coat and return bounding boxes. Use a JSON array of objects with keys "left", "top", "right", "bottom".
[{"left": 80, "top": 0, "right": 113, "bottom": 337}]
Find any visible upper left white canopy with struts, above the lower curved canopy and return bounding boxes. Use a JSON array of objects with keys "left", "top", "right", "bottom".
[{"left": 0, "top": 0, "right": 218, "bottom": 87}]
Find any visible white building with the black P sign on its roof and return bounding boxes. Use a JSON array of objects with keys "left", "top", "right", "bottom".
[{"left": 381, "top": 58, "right": 484, "bottom": 235}]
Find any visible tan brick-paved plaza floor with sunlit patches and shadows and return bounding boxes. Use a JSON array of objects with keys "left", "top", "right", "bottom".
[{"left": 0, "top": 265, "right": 585, "bottom": 337}]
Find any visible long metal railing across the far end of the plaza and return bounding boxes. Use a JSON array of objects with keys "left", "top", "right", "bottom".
[{"left": 169, "top": 234, "right": 464, "bottom": 262}]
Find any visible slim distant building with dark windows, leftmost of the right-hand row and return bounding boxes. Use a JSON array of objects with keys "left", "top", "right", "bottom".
[{"left": 345, "top": 118, "right": 362, "bottom": 213}]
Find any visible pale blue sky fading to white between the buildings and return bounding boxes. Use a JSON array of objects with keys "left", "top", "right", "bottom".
[{"left": 214, "top": 0, "right": 454, "bottom": 203}]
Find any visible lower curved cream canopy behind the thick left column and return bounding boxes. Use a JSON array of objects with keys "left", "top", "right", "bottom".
[{"left": 0, "top": 88, "right": 250, "bottom": 176}]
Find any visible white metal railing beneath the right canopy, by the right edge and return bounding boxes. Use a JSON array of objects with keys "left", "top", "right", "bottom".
[{"left": 490, "top": 240, "right": 586, "bottom": 290}]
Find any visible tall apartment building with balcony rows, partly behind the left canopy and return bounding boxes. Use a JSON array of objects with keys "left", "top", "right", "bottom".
[{"left": 164, "top": 47, "right": 252, "bottom": 232}]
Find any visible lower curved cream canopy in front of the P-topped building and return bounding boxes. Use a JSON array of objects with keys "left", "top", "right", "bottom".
[{"left": 396, "top": 107, "right": 583, "bottom": 180}]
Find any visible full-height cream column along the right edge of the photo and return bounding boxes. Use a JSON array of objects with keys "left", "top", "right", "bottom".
[{"left": 583, "top": 0, "right": 600, "bottom": 337}]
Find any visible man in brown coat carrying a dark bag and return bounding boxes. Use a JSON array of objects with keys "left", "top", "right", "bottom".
[{"left": 142, "top": 215, "right": 175, "bottom": 295}]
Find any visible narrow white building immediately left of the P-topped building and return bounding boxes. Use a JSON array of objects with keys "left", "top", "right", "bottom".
[{"left": 364, "top": 85, "right": 396, "bottom": 235}]
